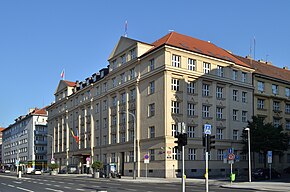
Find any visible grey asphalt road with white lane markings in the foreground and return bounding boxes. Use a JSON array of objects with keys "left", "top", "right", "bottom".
[{"left": 0, "top": 174, "right": 256, "bottom": 192}]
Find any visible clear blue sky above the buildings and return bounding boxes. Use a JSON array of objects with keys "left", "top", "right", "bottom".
[{"left": 0, "top": 0, "right": 290, "bottom": 127}]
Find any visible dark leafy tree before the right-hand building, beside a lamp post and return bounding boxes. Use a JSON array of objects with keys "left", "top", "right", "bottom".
[{"left": 242, "top": 116, "right": 289, "bottom": 168}]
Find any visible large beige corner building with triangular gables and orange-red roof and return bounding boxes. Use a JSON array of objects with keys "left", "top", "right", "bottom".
[{"left": 48, "top": 32, "right": 254, "bottom": 178}]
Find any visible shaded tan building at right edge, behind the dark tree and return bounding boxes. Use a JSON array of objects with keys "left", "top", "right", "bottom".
[{"left": 236, "top": 56, "right": 290, "bottom": 170}]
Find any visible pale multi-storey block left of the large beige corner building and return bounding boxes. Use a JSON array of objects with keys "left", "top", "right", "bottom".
[{"left": 2, "top": 108, "right": 47, "bottom": 171}]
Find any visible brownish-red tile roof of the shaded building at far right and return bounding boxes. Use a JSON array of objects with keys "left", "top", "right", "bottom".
[{"left": 234, "top": 55, "right": 290, "bottom": 82}]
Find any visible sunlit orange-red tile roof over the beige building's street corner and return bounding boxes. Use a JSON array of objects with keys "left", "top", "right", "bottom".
[{"left": 149, "top": 32, "right": 250, "bottom": 67}]
